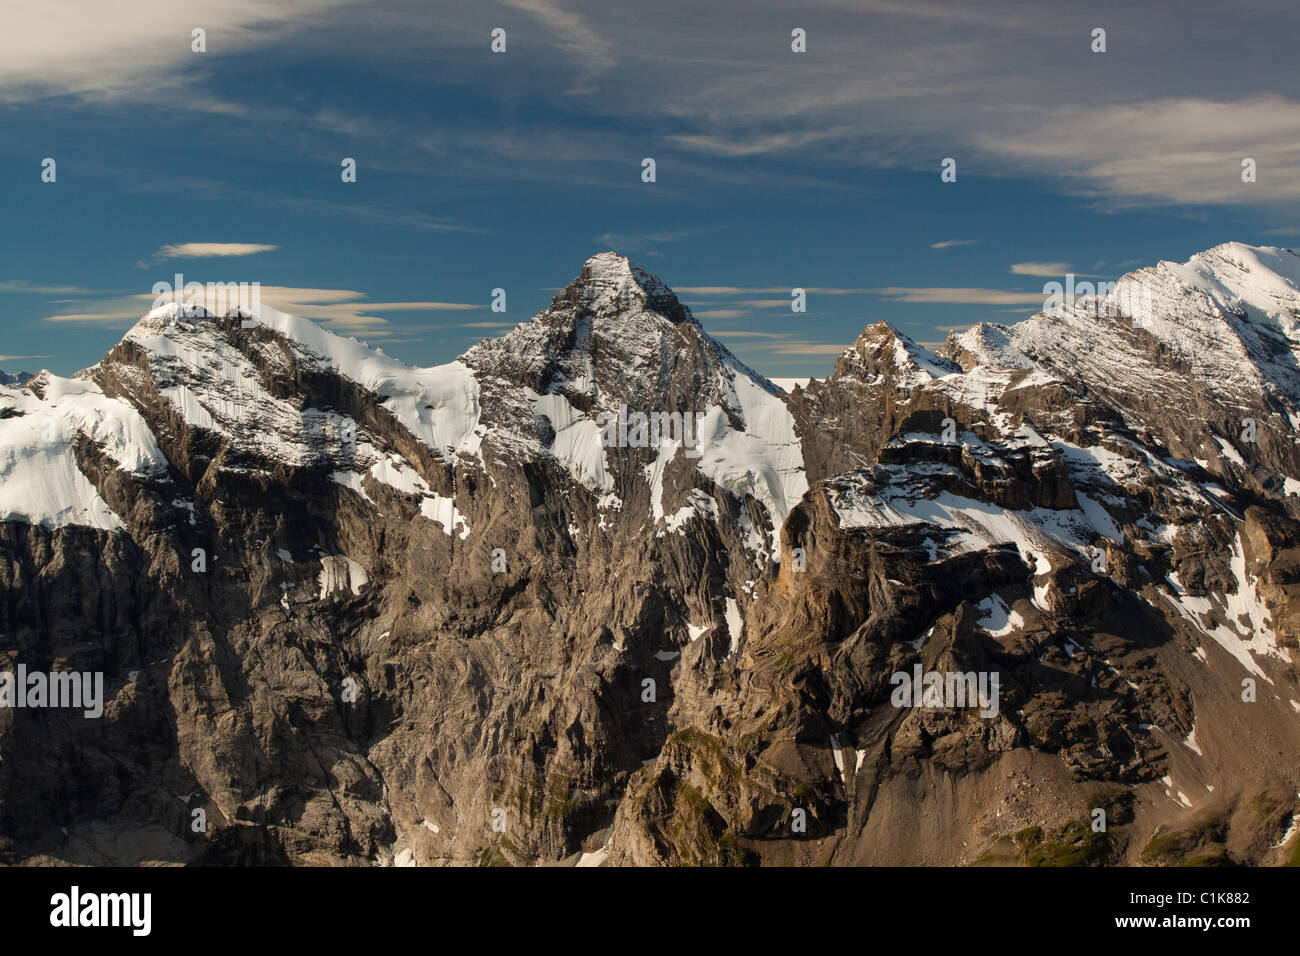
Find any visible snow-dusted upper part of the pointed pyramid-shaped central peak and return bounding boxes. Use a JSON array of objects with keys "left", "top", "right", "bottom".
[{"left": 463, "top": 252, "right": 807, "bottom": 555}]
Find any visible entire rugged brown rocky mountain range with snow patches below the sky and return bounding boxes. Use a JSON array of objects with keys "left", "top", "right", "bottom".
[{"left": 0, "top": 243, "right": 1300, "bottom": 865}]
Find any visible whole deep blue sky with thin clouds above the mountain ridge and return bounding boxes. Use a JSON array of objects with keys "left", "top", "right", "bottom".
[{"left": 0, "top": 0, "right": 1300, "bottom": 377}]
